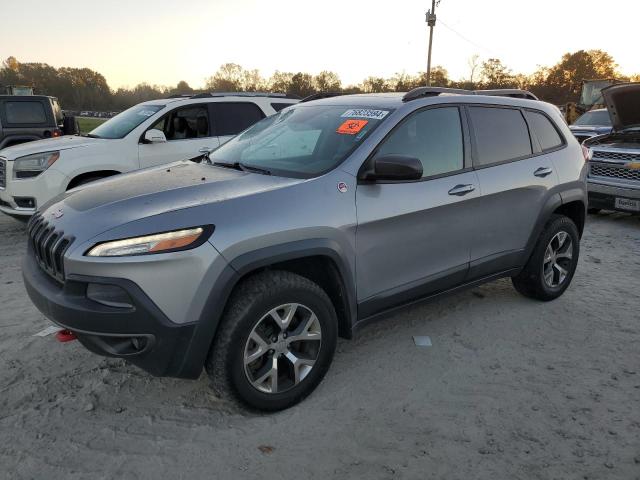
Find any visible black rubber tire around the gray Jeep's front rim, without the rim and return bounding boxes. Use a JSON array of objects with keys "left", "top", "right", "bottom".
[{"left": 205, "top": 271, "right": 338, "bottom": 411}]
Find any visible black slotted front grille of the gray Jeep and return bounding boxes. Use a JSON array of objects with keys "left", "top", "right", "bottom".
[{"left": 27, "top": 213, "right": 73, "bottom": 282}]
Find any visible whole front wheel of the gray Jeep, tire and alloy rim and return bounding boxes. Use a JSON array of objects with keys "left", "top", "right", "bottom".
[{"left": 205, "top": 271, "right": 338, "bottom": 411}]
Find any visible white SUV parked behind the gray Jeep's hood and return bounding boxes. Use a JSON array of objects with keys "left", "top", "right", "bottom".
[{"left": 0, "top": 93, "right": 298, "bottom": 218}]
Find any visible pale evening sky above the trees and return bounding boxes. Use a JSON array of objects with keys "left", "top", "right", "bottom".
[{"left": 0, "top": 0, "right": 640, "bottom": 88}]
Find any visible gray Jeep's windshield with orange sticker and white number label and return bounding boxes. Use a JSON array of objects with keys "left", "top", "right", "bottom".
[{"left": 209, "top": 105, "right": 391, "bottom": 178}]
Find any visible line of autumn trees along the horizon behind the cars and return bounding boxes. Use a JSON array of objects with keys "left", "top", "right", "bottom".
[{"left": 0, "top": 50, "right": 640, "bottom": 111}]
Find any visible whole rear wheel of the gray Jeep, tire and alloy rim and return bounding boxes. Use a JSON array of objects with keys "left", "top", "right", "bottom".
[{"left": 511, "top": 215, "right": 580, "bottom": 301}]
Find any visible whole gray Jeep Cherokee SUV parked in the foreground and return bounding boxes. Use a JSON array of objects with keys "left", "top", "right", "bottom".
[{"left": 23, "top": 87, "right": 586, "bottom": 410}]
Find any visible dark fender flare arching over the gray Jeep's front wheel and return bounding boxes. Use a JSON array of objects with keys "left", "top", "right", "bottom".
[{"left": 178, "top": 238, "right": 357, "bottom": 378}]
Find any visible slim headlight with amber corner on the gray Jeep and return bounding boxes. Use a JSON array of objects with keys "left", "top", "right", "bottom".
[{"left": 86, "top": 227, "right": 211, "bottom": 257}]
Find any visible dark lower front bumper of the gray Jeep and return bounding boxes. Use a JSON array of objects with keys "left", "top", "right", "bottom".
[{"left": 22, "top": 251, "right": 202, "bottom": 378}]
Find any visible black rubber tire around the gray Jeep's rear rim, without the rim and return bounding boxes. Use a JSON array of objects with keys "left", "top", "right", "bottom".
[{"left": 511, "top": 215, "right": 580, "bottom": 301}]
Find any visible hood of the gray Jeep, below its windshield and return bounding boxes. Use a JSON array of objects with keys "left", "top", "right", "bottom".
[{"left": 42, "top": 161, "right": 304, "bottom": 244}]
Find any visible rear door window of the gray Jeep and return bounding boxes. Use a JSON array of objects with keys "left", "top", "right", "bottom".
[{"left": 469, "top": 107, "right": 533, "bottom": 166}]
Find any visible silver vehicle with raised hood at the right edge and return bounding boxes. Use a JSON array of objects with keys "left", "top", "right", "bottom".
[{"left": 583, "top": 83, "right": 640, "bottom": 213}]
